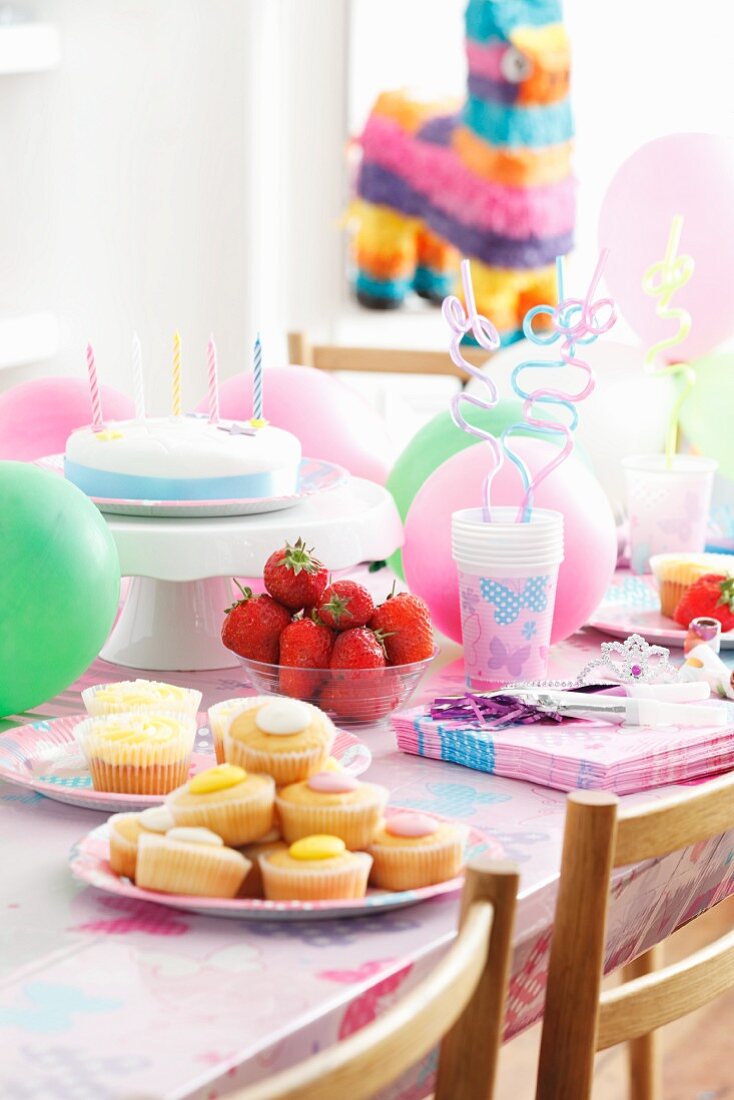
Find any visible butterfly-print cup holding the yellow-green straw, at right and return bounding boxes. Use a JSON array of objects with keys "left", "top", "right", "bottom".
[{"left": 622, "top": 454, "right": 719, "bottom": 573}]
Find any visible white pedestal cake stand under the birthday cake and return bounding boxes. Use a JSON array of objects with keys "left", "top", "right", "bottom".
[{"left": 100, "top": 477, "right": 403, "bottom": 671}]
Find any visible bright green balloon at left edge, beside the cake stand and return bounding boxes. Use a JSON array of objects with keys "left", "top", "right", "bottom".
[{"left": 0, "top": 462, "right": 120, "bottom": 715}]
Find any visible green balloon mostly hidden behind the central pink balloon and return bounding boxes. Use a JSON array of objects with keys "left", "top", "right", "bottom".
[{"left": 387, "top": 397, "right": 583, "bottom": 580}]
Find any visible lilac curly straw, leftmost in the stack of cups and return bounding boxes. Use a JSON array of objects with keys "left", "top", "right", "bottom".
[{"left": 441, "top": 260, "right": 504, "bottom": 524}]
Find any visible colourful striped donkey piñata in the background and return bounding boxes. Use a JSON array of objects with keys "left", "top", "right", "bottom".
[{"left": 354, "top": 0, "right": 576, "bottom": 342}]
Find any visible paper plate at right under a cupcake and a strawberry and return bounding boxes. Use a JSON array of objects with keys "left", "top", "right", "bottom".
[{"left": 587, "top": 574, "right": 734, "bottom": 649}]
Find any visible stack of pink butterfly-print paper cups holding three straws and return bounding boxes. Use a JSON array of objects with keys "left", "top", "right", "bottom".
[{"left": 451, "top": 507, "right": 563, "bottom": 690}]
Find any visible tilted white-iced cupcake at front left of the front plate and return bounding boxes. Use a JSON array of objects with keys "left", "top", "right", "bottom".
[{"left": 135, "top": 828, "right": 251, "bottom": 898}]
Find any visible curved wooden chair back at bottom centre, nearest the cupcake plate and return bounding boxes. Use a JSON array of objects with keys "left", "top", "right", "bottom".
[{"left": 228, "top": 860, "right": 519, "bottom": 1100}]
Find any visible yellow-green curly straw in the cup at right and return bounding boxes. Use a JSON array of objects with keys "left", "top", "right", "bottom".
[{"left": 643, "top": 215, "right": 695, "bottom": 470}]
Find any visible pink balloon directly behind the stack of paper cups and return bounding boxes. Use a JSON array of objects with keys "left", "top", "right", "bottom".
[{"left": 403, "top": 439, "right": 617, "bottom": 641}]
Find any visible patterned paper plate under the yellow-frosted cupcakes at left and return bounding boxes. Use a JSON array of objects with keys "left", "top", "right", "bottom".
[{"left": 0, "top": 714, "right": 372, "bottom": 814}]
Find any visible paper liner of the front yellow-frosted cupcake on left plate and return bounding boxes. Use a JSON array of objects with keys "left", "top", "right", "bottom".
[{"left": 74, "top": 711, "right": 196, "bottom": 794}]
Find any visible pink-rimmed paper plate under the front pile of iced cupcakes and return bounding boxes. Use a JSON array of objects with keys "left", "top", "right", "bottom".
[{"left": 69, "top": 806, "right": 504, "bottom": 921}]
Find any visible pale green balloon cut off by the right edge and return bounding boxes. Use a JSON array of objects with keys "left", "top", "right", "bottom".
[{"left": 680, "top": 354, "right": 734, "bottom": 480}]
